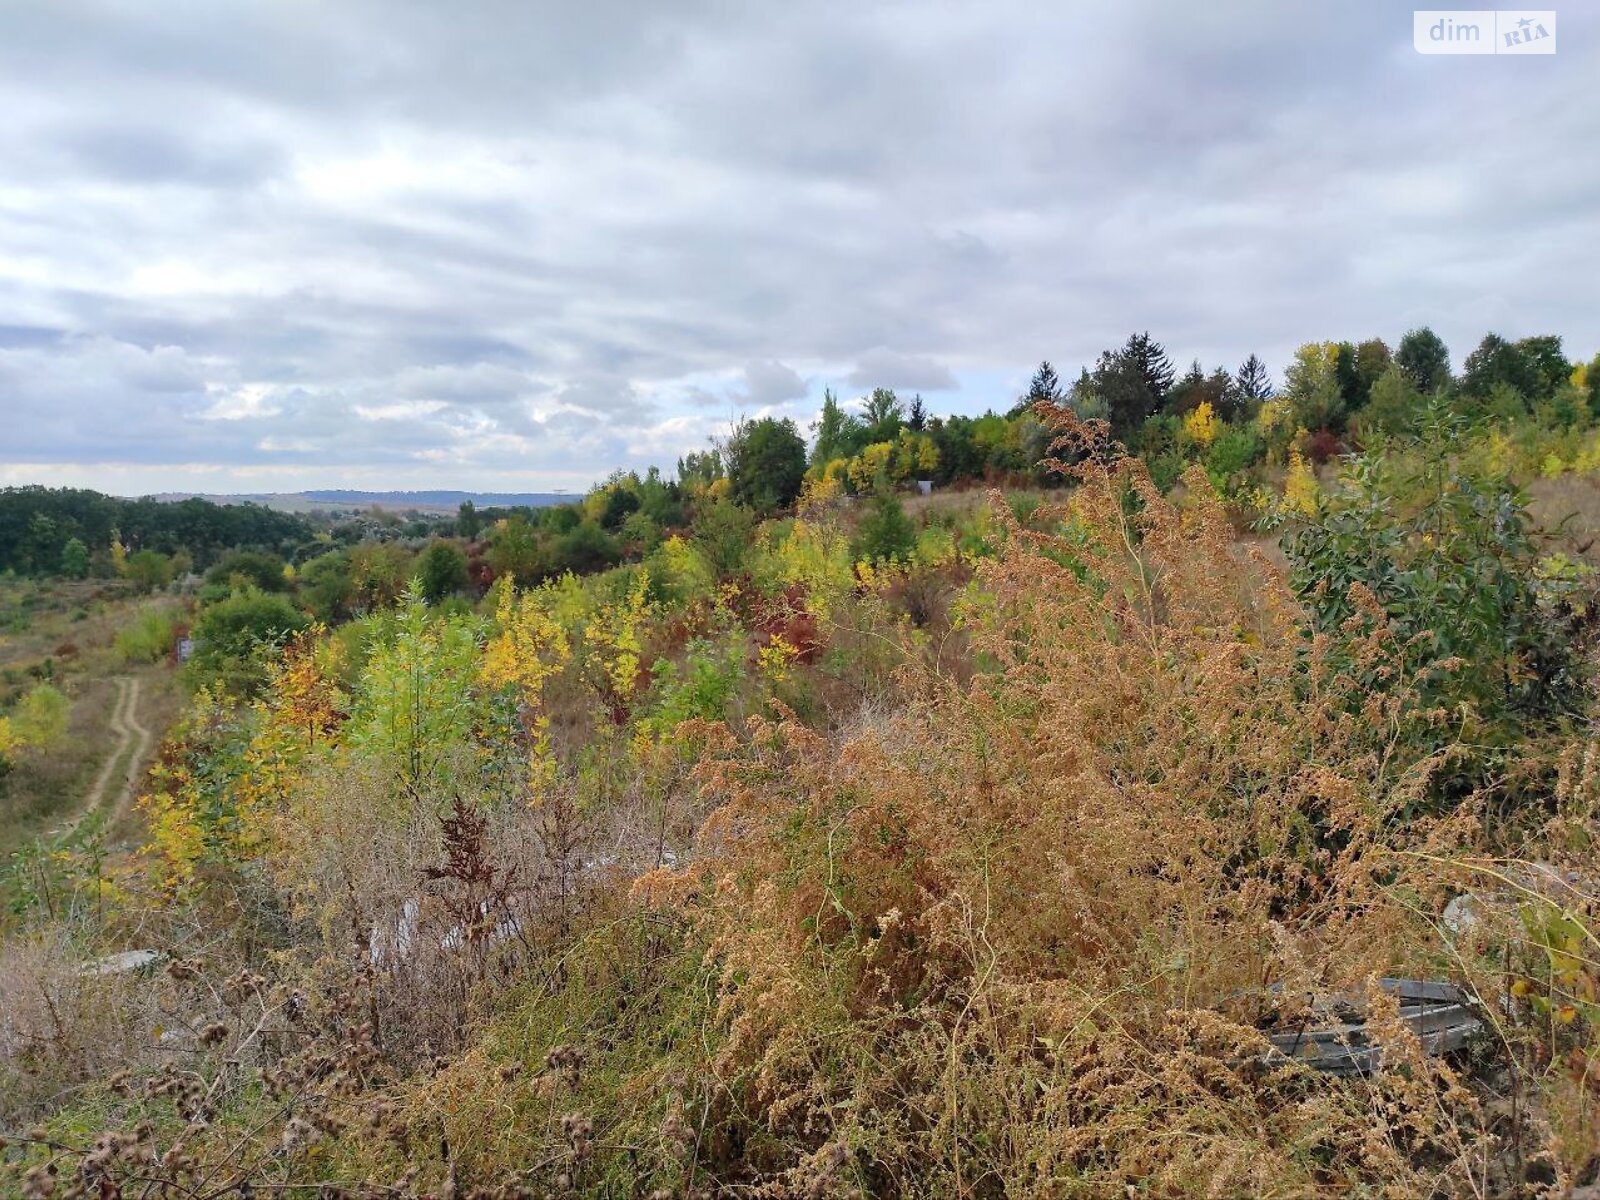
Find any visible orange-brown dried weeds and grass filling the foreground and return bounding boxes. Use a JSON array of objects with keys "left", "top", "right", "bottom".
[{"left": 0, "top": 448, "right": 1600, "bottom": 1200}]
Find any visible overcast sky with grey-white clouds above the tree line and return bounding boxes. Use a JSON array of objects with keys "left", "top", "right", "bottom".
[{"left": 0, "top": 0, "right": 1600, "bottom": 493}]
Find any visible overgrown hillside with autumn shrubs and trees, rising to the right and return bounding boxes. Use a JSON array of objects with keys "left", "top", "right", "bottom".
[{"left": 0, "top": 334, "right": 1600, "bottom": 1197}]
